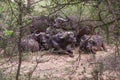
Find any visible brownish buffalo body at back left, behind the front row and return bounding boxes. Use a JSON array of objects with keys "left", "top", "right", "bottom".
[{"left": 30, "top": 16, "right": 54, "bottom": 33}]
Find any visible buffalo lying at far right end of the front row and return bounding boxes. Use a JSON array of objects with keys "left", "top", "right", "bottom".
[{"left": 79, "top": 35, "right": 107, "bottom": 54}]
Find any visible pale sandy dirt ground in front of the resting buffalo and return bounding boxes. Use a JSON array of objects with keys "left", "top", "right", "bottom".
[{"left": 0, "top": 46, "right": 120, "bottom": 80}]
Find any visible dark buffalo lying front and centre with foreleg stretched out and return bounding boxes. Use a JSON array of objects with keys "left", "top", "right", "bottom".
[{"left": 51, "top": 31, "right": 76, "bottom": 57}]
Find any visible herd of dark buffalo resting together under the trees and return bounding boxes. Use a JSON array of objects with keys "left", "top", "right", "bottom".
[{"left": 20, "top": 16, "right": 107, "bottom": 57}]
